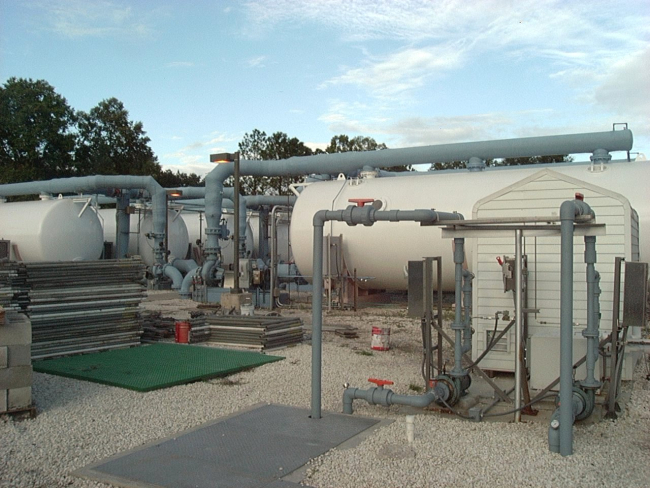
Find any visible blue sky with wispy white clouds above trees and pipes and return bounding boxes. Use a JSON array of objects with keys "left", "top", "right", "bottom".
[{"left": 0, "top": 0, "right": 650, "bottom": 175}]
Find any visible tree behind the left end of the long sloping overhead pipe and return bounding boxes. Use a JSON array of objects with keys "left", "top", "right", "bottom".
[{"left": 235, "top": 129, "right": 314, "bottom": 195}]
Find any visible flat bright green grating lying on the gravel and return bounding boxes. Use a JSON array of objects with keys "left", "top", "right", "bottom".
[{"left": 33, "top": 343, "right": 284, "bottom": 391}]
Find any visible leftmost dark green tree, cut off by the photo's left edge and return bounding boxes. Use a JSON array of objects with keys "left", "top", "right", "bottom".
[{"left": 0, "top": 78, "right": 78, "bottom": 183}]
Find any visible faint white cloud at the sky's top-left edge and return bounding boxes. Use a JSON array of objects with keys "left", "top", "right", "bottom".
[{"left": 32, "top": 0, "right": 159, "bottom": 38}]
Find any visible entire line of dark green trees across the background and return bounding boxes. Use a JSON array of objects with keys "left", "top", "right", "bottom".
[{"left": 0, "top": 77, "right": 570, "bottom": 195}]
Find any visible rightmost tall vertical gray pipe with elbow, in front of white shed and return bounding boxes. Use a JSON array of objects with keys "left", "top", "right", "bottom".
[{"left": 556, "top": 194, "right": 595, "bottom": 456}]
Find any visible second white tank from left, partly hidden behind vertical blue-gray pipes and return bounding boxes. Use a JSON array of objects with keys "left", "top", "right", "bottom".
[{"left": 99, "top": 208, "right": 190, "bottom": 266}]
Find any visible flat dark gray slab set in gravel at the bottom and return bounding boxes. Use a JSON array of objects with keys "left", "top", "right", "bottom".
[{"left": 73, "top": 404, "right": 379, "bottom": 488}]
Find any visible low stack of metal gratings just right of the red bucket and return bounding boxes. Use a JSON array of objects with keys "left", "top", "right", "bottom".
[{"left": 191, "top": 315, "right": 303, "bottom": 351}]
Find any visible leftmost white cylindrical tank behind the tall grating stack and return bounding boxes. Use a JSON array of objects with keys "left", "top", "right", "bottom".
[{"left": 0, "top": 198, "right": 104, "bottom": 262}]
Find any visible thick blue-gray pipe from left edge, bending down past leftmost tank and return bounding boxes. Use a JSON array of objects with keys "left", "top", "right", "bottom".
[{"left": 0, "top": 176, "right": 167, "bottom": 267}]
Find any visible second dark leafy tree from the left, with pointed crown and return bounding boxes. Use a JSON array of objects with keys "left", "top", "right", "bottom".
[{"left": 76, "top": 98, "right": 161, "bottom": 175}]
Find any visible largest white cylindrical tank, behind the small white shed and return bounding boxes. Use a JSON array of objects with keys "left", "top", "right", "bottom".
[{"left": 290, "top": 161, "right": 650, "bottom": 290}]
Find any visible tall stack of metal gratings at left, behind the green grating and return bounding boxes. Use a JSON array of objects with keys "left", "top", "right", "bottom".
[{"left": 24, "top": 259, "right": 146, "bottom": 359}]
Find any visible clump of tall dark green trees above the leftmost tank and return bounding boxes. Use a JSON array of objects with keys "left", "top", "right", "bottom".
[{"left": 0, "top": 78, "right": 201, "bottom": 186}]
